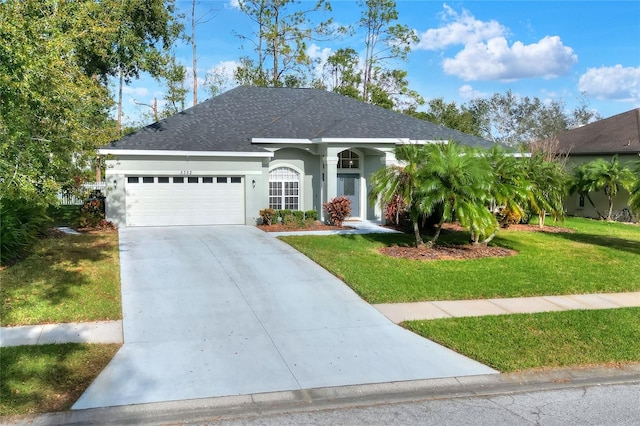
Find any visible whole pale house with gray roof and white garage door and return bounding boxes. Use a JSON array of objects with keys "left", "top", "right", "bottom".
[{"left": 99, "top": 87, "right": 491, "bottom": 226}]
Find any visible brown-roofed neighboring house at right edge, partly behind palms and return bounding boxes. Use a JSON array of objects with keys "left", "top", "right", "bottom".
[{"left": 557, "top": 108, "right": 640, "bottom": 218}]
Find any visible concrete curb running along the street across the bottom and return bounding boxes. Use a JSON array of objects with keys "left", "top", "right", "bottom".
[{"left": 5, "top": 363, "right": 640, "bottom": 425}]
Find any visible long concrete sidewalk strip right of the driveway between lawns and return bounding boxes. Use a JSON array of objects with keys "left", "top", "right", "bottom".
[{"left": 373, "top": 291, "right": 640, "bottom": 324}]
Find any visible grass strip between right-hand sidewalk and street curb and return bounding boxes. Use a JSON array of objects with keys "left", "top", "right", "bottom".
[{"left": 403, "top": 308, "right": 640, "bottom": 372}]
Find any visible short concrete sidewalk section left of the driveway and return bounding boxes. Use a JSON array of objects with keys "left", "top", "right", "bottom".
[{"left": 0, "top": 321, "right": 123, "bottom": 347}]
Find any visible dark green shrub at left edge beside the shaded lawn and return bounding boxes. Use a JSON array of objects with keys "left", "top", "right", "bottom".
[{"left": 0, "top": 198, "right": 51, "bottom": 265}]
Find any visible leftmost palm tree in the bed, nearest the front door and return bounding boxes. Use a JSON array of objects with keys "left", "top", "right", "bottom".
[{"left": 369, "top": 145, "right": 426, "bottom": 247}]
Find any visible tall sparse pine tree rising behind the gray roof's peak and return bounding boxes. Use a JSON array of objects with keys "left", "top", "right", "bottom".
[{"left": 236, "top": 0, "right": 332, "bottom": 87}]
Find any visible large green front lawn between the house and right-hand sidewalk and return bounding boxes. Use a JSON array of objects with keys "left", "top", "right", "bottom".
[{"left": 281, "top": 218, "right": 640, "bottom": 303}]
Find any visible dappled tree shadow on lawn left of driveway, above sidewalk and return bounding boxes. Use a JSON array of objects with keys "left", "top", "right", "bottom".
[{"left": 1, "top": 234, "right": 117, "bottom": 323}]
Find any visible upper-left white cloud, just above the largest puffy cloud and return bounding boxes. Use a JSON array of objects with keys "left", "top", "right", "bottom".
[{"left": 416, "top": 4, "right": 507, "bottom": 50}]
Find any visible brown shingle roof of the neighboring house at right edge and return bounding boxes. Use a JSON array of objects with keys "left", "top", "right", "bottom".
[{"left": 557, "top": 108, "right": 640, "bottom": 155}]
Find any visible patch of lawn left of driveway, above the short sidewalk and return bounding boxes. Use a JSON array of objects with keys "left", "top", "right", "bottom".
[{"left": 0, "top": 232, "right": 122, "bottom": 326}]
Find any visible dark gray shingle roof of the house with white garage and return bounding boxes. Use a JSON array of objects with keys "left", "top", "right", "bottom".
[{"left": 105, "top": 86, "right": 492, "bottom": 152}]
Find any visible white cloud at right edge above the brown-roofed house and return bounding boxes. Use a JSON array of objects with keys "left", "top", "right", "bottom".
[{"left": 578, "top": 65, "right": 640, "bottom": 103}]
